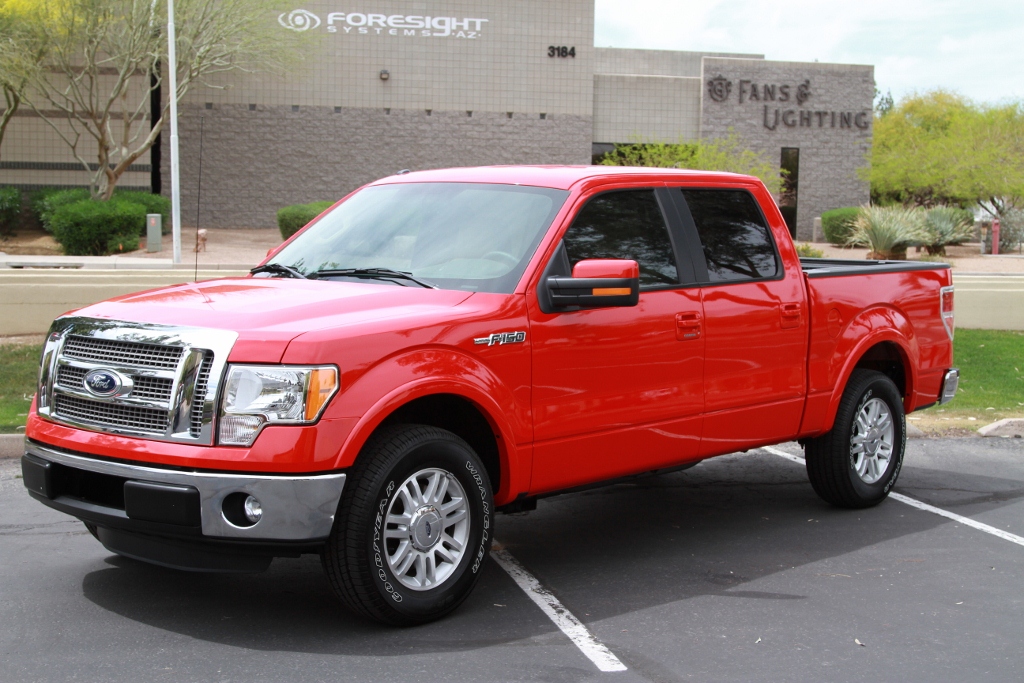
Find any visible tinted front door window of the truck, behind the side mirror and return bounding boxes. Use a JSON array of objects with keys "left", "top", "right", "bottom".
[{"left": 562, "top": 189, "right": 679, "bottom": 287}]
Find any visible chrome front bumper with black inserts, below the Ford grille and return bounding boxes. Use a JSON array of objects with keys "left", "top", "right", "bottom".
[{"left": 22, "top": 439, "right": 345, "bottom": 563}]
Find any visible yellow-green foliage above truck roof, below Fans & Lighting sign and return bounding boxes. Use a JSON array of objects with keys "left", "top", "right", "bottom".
[{"left": 600, "top": 132, "right": 781, "bottom": 193}]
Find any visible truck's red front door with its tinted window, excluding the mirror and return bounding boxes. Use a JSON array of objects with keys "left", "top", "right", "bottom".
[{"left": 529, "top": 188, "right": 705, "bottom": 493}]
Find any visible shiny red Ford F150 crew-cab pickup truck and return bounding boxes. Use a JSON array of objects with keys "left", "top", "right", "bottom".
[{"left": 23, "top": 167, "right": 958, "bottom": 625}]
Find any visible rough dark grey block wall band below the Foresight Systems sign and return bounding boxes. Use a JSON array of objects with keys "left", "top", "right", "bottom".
[{"left": 163, "top": 104, "right": 592, "bottom": 227}]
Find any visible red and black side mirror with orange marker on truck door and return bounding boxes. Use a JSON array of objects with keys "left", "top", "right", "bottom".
[{"left": 544, "top": 258, "right": 640, "bottom": 310}]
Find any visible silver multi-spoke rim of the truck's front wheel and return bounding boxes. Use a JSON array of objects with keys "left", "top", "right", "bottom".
[{"left": 384, "top": 468, "right": 469, "bottom": 591}]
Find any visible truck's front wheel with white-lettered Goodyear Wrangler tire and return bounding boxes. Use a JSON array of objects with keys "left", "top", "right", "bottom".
[{"left": 321, "top": 425, "right": 494, "bottom": 626}]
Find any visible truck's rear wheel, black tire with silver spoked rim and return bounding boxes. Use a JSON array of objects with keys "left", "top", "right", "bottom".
[{"left": 805, "top": 370, "right": 906, "bottom": 509}]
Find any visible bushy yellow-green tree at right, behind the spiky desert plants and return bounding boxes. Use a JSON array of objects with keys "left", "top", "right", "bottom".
[{"left": 867, "top": 90, "right": 1024, "bottom": 216}]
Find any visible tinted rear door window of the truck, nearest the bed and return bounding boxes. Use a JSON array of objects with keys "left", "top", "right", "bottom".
[{"left": 683, "top": 189, "right": 778, "bottom": 283}]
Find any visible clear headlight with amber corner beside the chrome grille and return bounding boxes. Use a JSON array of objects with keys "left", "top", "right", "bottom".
[{"left": 219, "top": 366, "right": 338, "bottom": 445}]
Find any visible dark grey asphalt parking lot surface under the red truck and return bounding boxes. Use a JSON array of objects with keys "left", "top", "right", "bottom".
[{"left": 0, "top": 438, "right": 1024, "bottom": 683}]
